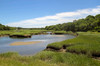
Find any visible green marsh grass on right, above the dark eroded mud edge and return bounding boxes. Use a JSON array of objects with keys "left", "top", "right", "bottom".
[{"left": 47, "top": 32, "right": 100, "bottom": 56}]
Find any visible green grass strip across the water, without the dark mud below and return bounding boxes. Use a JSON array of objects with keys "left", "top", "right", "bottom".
[{"left": 0, "top": 30, "right": 72, "bottom": 36}]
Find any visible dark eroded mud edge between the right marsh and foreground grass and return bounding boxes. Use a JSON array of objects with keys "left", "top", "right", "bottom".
[{"left": 45, "top": 45, "right": 100, "bottom": 60}]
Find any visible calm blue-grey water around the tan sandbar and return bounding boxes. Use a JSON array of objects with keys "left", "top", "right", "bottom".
[{"left": 0, "top": 35, "right": 75, "bottom": 55}]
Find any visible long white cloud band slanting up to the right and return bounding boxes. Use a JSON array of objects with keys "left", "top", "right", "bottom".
[{"left": 7, "top": 6, "right": 100, "bottom": 28}]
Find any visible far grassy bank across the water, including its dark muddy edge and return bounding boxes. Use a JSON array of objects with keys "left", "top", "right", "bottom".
[{"left": 0, "top": 29, "right": 74, "bottom": 38}]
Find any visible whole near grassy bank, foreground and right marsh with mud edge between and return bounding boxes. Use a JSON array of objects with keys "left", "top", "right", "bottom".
[{"left": 0, "top": 32, "right": 100, "bottom": 66}]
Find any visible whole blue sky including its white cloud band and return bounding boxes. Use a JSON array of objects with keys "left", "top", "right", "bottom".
[{"left": 0, "top": 0, "right": 100, "bottom": 28}]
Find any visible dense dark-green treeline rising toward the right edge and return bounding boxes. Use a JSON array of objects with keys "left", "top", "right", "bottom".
[{"left": 45, "top": 14, "right": 100, "bottom": 32}]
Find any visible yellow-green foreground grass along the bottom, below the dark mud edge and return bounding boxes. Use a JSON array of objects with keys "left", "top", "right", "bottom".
[{"left": 0, "top": 51, "right": 100, "bottom": 66}]
